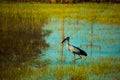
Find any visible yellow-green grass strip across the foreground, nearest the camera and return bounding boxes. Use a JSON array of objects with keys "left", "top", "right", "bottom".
[{"left": 0, "top": 56, "right": 120, "bottom": 80}]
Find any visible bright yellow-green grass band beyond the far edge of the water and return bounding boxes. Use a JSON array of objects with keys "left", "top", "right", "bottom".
[{"left": 0, "top": 3, "right": 120, "bottom": 24}]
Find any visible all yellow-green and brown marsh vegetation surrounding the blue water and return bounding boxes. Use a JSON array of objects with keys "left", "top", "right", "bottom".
[{"left": 0, "top": 2, "right": 120, "bottom": 80}]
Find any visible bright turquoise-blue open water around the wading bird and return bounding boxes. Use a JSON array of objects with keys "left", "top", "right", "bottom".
[{"left": 43, "top": 17, "right": 120, "bottom": 64}]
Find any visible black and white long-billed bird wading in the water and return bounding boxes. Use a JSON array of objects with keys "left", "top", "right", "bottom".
[{"left": 62, "top": 37, "right": 87, "bottom": 60}]
